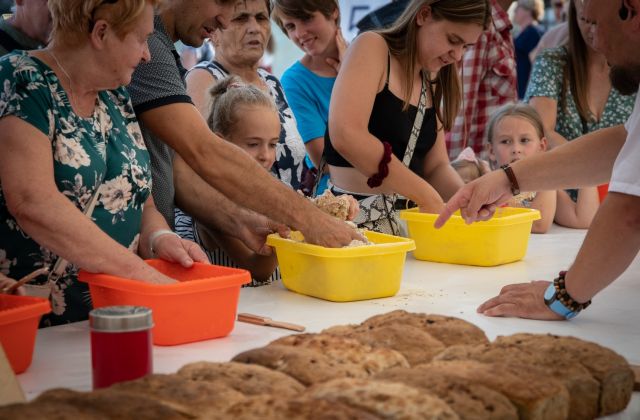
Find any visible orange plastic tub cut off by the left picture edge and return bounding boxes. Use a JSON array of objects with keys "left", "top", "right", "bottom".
[{"left": 0, "top": 294, "right": 51, "bottom": 373}]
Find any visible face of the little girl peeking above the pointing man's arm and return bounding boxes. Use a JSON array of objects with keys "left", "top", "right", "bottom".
[{"left": 489, "top": 116, "right": 547, "bottom": 165}]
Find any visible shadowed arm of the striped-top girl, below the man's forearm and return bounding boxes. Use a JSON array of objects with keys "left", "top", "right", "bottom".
[{"left": 198, "top": 226, "right": 278, "bottom": 282}]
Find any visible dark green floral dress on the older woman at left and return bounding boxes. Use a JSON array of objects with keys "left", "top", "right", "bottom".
[{"left": 0, "top": 52, "right": 151, "bottom": 326}]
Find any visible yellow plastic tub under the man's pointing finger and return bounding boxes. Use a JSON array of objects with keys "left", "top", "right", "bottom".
[{"left": 400, "top": 207, "right": 540, "bottom": 267}]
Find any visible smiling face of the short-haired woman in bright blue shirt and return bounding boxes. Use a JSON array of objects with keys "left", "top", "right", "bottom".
[{"left": 282, "top": 10, "right": 338, "bottom": 57}]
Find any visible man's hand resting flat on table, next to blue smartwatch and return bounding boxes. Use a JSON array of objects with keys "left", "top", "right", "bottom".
[{"left": 478, "top": 281, "right": 564, "bottom": 321}]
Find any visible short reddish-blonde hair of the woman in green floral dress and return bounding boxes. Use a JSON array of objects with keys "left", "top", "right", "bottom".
[{"left": 49, "top": 0, "right": 163, "bottom": 45}]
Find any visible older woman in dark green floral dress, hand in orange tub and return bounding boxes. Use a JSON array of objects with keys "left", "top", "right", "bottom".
[{"left": 0, "top": 0, "right": 206, "bottom": 326}]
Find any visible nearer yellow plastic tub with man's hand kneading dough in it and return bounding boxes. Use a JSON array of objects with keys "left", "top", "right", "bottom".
[{"left": 267, "top": 232, "right": 415, "bottom": 302}]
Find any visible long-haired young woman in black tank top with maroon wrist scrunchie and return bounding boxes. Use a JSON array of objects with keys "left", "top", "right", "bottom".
[{"left": 325, "top": 0, "right": 490, "bottom": 233}]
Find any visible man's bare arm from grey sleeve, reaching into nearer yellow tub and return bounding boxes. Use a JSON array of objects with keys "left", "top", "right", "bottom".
[{"left": 138, "top": 103, "right": 358, "bottom": 247}]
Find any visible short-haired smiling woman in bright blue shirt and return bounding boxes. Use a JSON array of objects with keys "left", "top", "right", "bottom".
[{"left": 272, "top": 0, "right": 347, "bottom": 193}]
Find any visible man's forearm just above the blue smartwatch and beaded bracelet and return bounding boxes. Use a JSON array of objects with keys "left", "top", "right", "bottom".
[{"left": 566, "top": 192, "right": 640, "bottom": 302}]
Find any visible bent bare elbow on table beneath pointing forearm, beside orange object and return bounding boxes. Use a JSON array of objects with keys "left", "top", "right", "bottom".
[{"left": 555, "top": 187, "right": 600, "bottom": 229}]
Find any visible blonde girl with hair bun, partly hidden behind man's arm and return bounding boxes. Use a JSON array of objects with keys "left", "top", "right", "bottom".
[{"left": 181, "top": 76, "right": 281, "bottom": 286}]
